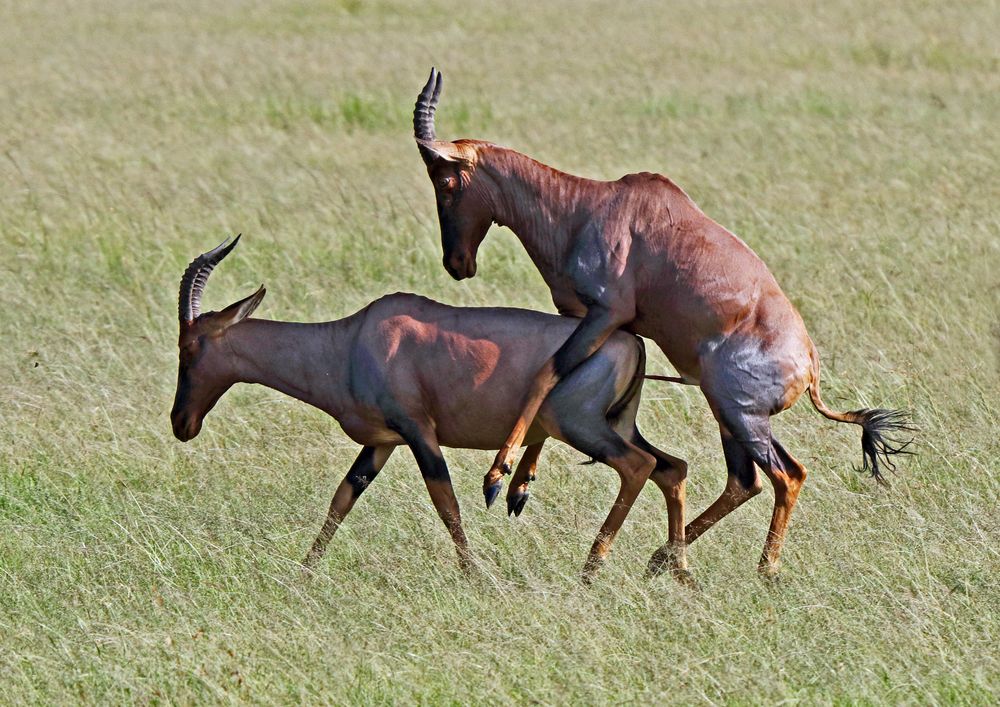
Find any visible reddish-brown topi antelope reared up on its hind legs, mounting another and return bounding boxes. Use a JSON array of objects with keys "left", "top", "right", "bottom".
[{"left": 413, "top": 69, "right": 911, "bottom": 576}]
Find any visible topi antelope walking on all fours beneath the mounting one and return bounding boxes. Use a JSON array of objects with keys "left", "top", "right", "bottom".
[{"left": 170, "top": 236, "right": 689, "bottom": 582}]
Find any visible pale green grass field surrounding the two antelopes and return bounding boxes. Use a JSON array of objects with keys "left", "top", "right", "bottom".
[{"left": 0, "top": 0, "right": 1000, "bottom": 704}]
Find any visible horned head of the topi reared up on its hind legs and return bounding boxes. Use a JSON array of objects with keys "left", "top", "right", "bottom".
[{"left": 413, "top": 69, "right": 493, "bottom": 280}]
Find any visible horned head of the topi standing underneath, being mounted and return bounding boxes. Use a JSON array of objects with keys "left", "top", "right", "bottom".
[{"left": 170, "top": 236, "right": 266, "bottom": 442}]
